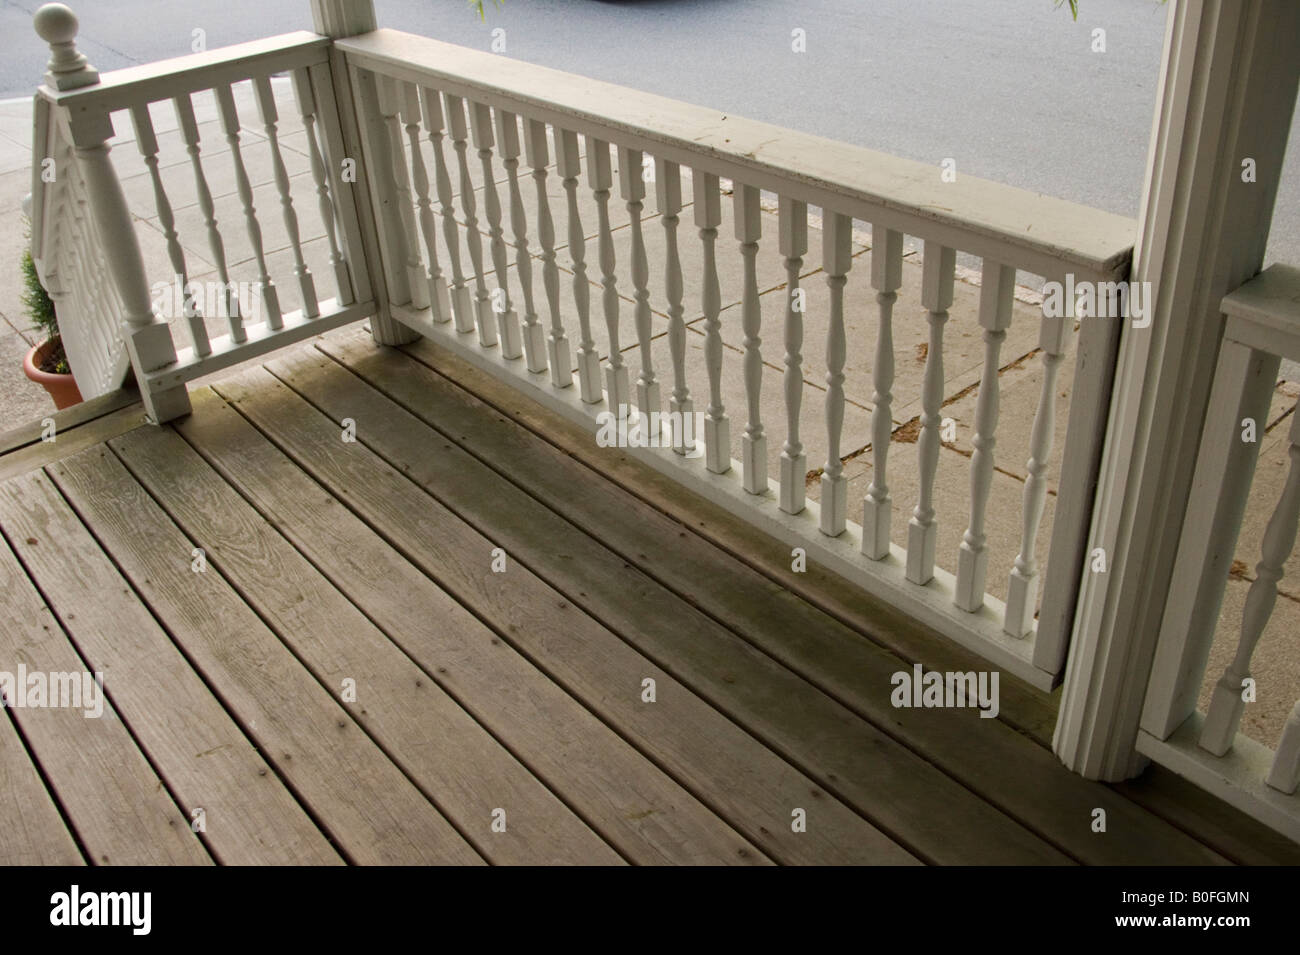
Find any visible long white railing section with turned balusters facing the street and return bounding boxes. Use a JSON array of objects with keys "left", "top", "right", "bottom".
[{"left": 335, "top": 30, "right": 1132, "bottom": 686}]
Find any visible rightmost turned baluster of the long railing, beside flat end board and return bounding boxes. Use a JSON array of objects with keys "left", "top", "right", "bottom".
[{"left": 1002, "top": 287, "right": 1074, "bottom": 637}]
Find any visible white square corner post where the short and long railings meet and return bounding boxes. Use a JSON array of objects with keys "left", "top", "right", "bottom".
[{"left": 311, "top": 0, "right": 420, "bottom": 346}]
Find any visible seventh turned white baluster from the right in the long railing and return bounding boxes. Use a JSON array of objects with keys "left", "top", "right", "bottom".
[{"left": 732, "top": 183, "right": 767, "bottom": 494}]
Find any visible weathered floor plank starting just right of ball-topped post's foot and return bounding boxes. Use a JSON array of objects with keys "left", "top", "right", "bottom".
[{"left": 179, "top": 390, "right": 764, "bottom": 864}]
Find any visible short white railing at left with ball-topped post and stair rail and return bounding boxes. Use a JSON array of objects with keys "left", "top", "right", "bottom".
[{"left": 34, "top": 5, "right": 376, "bottom": 421}]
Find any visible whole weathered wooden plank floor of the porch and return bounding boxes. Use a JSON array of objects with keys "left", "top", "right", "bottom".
[{"left": 0, "top": 327, "right": 1300, "bottom": 864}]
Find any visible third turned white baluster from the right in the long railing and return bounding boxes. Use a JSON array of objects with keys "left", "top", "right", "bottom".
[{"left": 907, "top": 242, "right": 957, "bottom": 583}]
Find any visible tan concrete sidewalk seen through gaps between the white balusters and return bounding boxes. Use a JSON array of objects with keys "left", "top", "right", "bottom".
[{"left": 0, "top": 82, "right": 1300, "bottom": 745}]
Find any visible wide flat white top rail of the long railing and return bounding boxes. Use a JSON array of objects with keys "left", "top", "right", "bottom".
[{"left": 335, "top": 30, "right": 1136, "bottom": 281}]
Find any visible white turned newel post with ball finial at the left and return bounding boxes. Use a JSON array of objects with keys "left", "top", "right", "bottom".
[{"left": 33, "top": 4, "right": 190, "bottom": 424}]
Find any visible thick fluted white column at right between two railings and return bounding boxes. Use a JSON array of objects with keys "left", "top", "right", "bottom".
[{"left": 1053, "top": 0, "right": 1300, "bottom": 780}]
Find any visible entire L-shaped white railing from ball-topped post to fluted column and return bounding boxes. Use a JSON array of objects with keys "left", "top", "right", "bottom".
[{"left": 25, "top": 6, "right": 1132, "bottom": 687}]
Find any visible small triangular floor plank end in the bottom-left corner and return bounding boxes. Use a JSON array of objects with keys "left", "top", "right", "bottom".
[{"left": 0, "top": 713, "right": 86, "bottom": 865}]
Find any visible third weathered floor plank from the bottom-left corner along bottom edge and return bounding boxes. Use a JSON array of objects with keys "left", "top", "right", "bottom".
[{"left": 0, "top": 467, "right": 337, "bottom": 865}]
